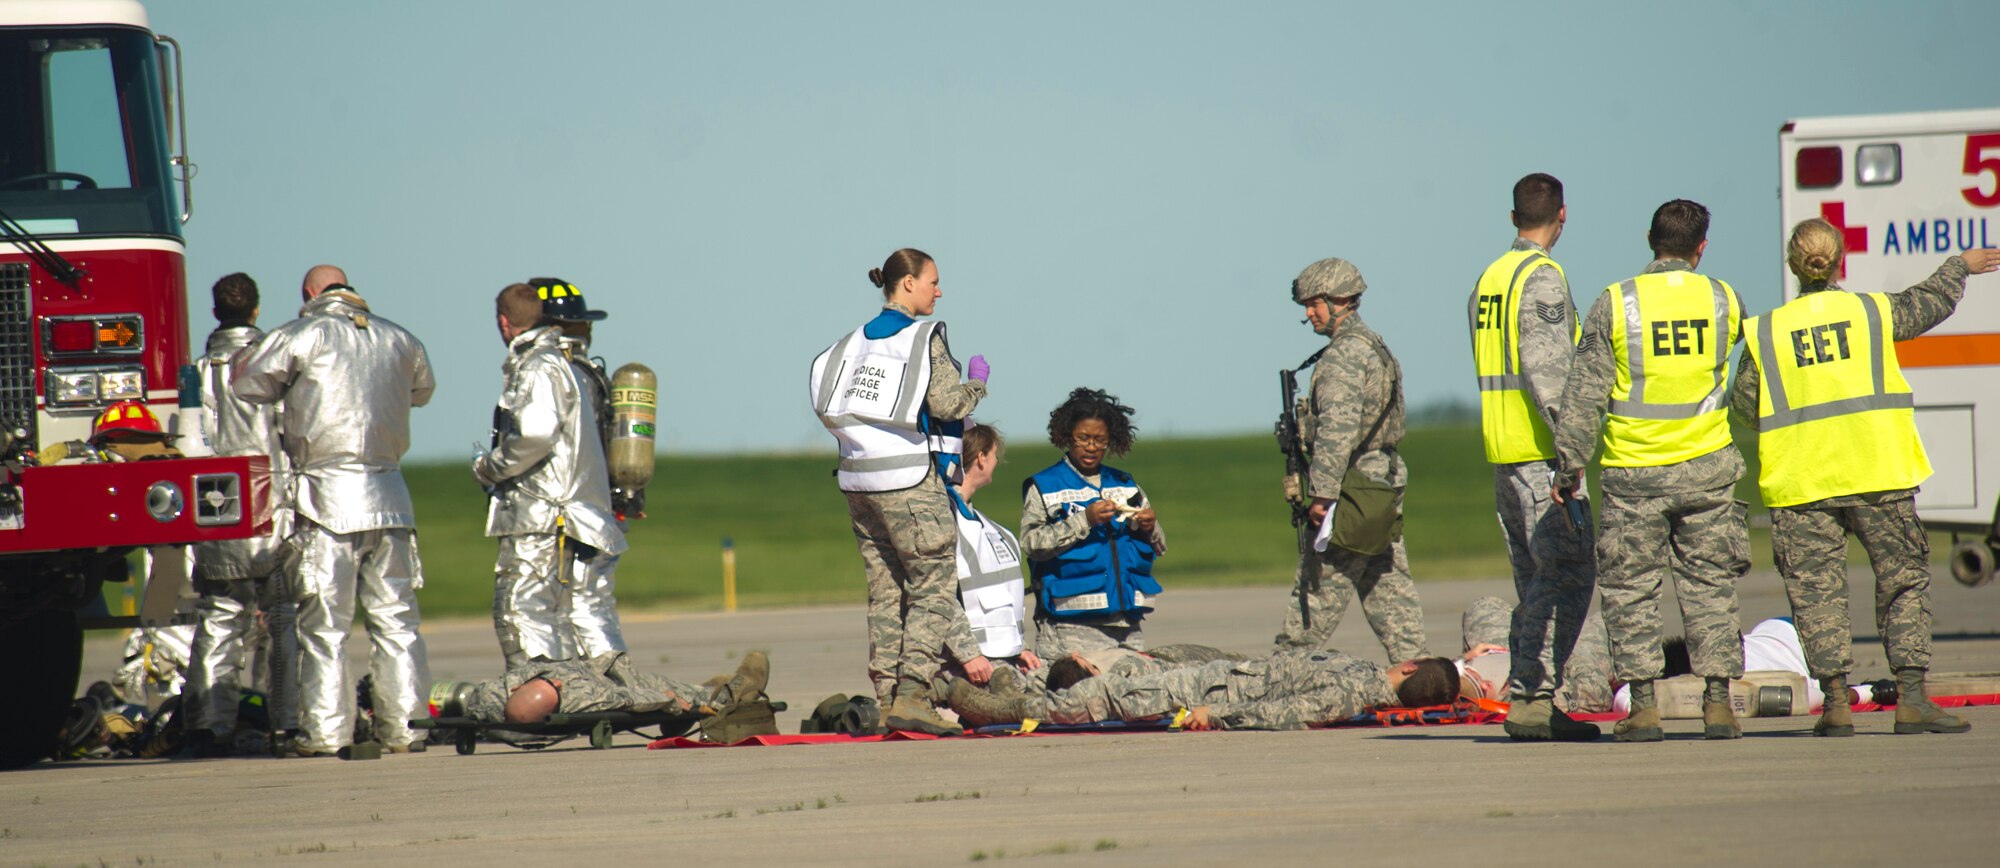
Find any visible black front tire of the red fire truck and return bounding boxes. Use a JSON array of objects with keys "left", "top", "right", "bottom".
[{"left": 0, "top": 610, "right": 84, "bottom": 770}]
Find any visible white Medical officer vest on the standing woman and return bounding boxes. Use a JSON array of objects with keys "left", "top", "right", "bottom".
[{"left": 810, "top": 322, "right": 944, "bottom": 492}]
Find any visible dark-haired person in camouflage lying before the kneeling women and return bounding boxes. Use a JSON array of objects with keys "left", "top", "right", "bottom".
[{"left": 950, "top": 650, "right": 1458, "bottom": 730}]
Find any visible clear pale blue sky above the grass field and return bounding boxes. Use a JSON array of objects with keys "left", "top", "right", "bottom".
[{"left": 150, "top": 0, "right": 2000, "bottom": 458}]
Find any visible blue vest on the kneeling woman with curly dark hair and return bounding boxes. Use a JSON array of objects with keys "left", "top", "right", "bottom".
[{"left": 1026, "top": 460, "right": 1160, "bottom": 620}]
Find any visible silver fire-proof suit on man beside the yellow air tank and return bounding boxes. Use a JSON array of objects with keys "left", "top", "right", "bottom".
[{"left": 472, "top": 326, "right": 626, "bottom": 666}]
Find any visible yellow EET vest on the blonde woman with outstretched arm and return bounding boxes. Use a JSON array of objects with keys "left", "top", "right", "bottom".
[{"left": 1744, "top": 290, "right": 1930, "bottom": 506}]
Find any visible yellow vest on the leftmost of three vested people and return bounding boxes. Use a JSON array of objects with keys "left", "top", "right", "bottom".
[{"left": 1470, "top": 250, "right": 1580, "bottom": 464}]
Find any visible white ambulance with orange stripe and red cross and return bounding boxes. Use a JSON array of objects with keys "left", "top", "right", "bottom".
[{"left": 1792, "top": 108, "right": 2000, "bottom": 584}]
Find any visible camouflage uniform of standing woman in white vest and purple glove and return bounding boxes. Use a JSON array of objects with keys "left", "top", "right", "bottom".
[{"left": 844, "top": 302, "right": 986, "bottom": 708}]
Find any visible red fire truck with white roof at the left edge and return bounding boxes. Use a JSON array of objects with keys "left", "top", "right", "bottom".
[{"left": 0, "top": 0, "right": 270, "bottom": 768}]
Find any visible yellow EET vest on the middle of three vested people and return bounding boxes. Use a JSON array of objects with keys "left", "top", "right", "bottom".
[{"left": 1604, "top": 272, "right": 1742, "bottom": 468}]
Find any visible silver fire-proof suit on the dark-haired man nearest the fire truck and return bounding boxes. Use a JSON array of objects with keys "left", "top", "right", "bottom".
[{"left": 186, "top": 324, "right": 298, "bottom": 734}]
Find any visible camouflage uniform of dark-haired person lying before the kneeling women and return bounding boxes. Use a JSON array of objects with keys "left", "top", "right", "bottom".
[{"left": 1048, "top": 650, "right": 1396, "bottom": 730}]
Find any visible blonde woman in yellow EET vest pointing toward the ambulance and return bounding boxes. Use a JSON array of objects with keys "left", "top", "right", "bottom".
[{"left": 1730, "top": 218, "right": 2000, "bottom": 736}]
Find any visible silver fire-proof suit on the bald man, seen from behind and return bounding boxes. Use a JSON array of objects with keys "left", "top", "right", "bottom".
[{"left": 232, "top": 290, "right": 436, "bottom": 752}]
